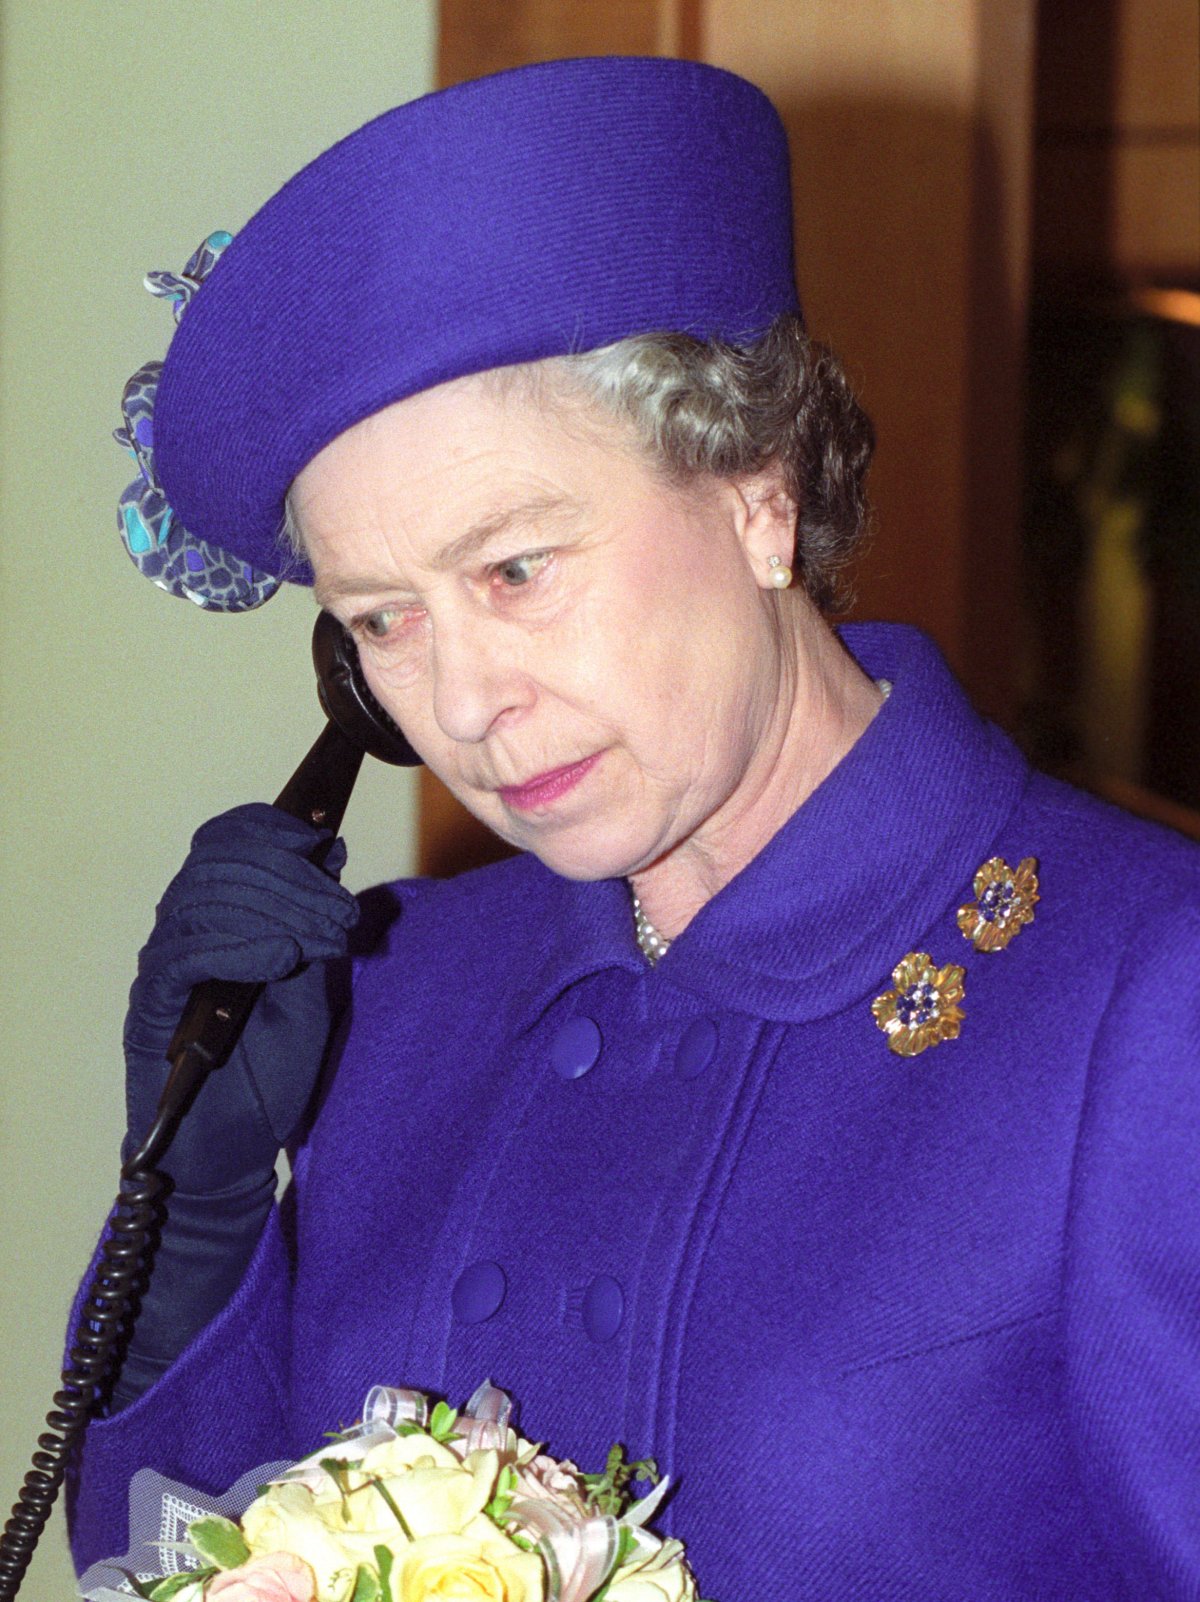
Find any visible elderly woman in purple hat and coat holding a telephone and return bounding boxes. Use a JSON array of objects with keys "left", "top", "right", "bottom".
[{"left": 65, "top": 59, "right": 1200, "bottom": 1602}]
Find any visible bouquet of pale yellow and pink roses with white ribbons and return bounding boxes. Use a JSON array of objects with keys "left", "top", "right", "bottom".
[{"left": 83, "top": 1383, "right": 697, "bottom": 1602}]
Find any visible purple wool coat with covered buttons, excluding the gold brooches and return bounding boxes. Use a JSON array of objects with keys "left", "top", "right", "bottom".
[{"left": 72, "top": 626, "right": 1200, "bottom": 1602}]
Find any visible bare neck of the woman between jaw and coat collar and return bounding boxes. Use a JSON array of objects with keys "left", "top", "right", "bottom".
[{"left": 630, "top": 594, "right": 883, "bottom": 940}]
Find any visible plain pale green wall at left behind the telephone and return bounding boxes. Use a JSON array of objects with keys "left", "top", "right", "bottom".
[{"left": 0, "top": 0, "right": 434, "bottom": 1599}]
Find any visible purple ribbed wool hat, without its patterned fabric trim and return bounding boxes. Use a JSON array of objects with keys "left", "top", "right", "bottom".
[{"left": 154, "top": 56, "right": 798, "bottom": 583}]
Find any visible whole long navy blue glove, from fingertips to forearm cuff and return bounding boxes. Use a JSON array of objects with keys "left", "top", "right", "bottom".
[{"left": 112, "top": 803, "right": 359, "bottom": 1410}]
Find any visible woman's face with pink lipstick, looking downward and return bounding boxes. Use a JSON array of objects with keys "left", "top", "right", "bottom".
[{"left": 292, "top": 376, "right": 790, "bottom": 879}]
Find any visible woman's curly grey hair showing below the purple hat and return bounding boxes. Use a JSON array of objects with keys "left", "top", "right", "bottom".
[{"left": 280, "top": 316, "right": 875, "bottom": 612}]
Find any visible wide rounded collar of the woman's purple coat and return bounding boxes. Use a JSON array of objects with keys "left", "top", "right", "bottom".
[{"left": 499, "top": 625, "right": 1029, "bottom": 1024}]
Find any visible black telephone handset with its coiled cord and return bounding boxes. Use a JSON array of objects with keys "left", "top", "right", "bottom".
[{"left": 0, "top": 612, "right": 421, "bottom": 1602}]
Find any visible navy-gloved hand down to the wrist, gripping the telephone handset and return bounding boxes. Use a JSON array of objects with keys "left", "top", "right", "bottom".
[{"left": 125, "top": 803, "right": 359, "bottom": 1195}]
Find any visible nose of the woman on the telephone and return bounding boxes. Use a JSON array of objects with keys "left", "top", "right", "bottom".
[{"left": 433, "top": 615, "right": 534, "bottom": 743}]
